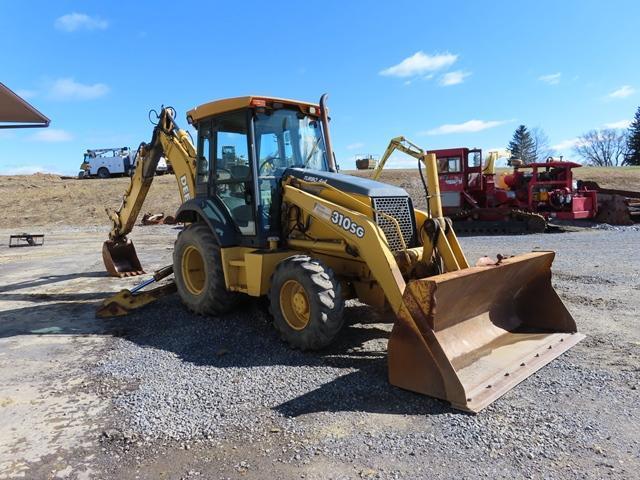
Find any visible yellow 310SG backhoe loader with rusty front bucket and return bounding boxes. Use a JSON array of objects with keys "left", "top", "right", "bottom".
[{"left": 99, "top": 96, "right": 583, "bottom": 412}]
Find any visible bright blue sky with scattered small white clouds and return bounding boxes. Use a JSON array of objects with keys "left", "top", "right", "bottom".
[{"left": 0, "top": 0, "right": 640, "bottom": 174}]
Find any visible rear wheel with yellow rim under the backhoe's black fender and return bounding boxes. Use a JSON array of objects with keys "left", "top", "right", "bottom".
[{"left": 173, "top": 223, "right": 241, "bottom": 315}]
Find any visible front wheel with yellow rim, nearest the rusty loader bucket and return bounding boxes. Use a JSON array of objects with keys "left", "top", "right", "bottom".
[{"left": 269, "top": 255, "right": 344, "bottom": 350}]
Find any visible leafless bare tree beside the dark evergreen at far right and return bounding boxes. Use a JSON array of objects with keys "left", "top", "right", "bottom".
[{"left": 573, "top": 128, "right": 627, "bottom": 167}]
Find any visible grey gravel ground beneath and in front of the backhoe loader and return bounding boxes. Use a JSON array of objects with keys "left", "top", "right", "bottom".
[{"left": 95, "top": 227, "right": 640, "bottom": 478}]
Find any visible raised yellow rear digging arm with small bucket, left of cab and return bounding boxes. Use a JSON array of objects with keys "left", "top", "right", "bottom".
[{"left": 102, "top": 108, "right": 196, "bottom": 277}]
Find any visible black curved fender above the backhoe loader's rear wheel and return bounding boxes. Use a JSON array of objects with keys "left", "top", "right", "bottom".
[{"left": 176, "top": 198, "right": 239, "bottom": 247}]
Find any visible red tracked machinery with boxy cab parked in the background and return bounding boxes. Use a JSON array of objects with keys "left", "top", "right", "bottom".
[{"left": 429, "top": 148, "right": 598, "bottom": 233}]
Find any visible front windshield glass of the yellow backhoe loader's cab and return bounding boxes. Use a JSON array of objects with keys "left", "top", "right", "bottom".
[{"left": 254, "top": 109, "right": 328, "bottom": 172}]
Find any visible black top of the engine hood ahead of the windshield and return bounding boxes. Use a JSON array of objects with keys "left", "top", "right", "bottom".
[{"left": 284, "top": 168, "right": 409, "bottom": 197}]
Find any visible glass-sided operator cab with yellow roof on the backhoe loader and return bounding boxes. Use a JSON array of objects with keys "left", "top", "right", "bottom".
[{"left": 187, "top": 97, "right": 331, "bottom": 246}]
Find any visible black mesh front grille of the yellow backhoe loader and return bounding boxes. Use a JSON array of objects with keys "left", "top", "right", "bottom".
[{"left": 372, "top": 197, "right": 416, "bottom": 252}]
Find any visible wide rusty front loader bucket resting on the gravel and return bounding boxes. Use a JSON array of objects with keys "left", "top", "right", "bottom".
[{"left": 389, "top": 252, "right": 584, "bottom": 412}]
